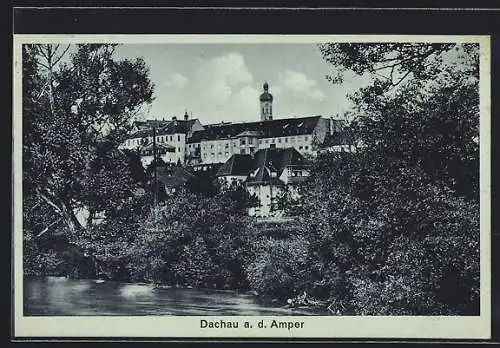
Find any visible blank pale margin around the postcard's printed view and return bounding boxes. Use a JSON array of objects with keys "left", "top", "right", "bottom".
[{"left": 12, "top": 35, "right": 491, "bottom": 339}]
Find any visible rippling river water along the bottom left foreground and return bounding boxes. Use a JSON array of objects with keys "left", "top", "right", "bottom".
[{"left": 24, "top": 277, "right": 326, "bottom": 316}]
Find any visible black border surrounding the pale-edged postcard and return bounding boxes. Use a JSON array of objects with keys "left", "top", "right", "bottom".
[{"left": 8, "top": 5, "right": 500, "bottom": 346}]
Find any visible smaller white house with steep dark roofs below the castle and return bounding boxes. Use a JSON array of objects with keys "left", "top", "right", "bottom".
[{"left": 216, "top": 147, "right": 309, "bottom": 217}]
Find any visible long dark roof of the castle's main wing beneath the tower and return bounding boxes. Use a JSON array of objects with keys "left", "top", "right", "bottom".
[{"left": 187, "top": 116, "right": 321, "bottom": 143}]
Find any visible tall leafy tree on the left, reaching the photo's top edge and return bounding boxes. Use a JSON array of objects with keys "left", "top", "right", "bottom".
[{"left": 23, "top": 44, "right": 153, "bottom": 238}]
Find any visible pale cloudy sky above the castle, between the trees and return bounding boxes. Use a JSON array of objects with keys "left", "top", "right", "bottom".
[{"left": 115, "top": 43, "right": 372, "bottom": 124}]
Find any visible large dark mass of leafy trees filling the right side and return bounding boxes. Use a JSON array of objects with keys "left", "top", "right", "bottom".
[{"left": 278, "top": 43, "right": 479, "bottom": 315}]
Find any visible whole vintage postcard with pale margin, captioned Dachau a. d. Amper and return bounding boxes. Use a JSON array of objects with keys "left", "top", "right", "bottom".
[{"left": 12, "top": 34, "right": 491, "bottom": 339}]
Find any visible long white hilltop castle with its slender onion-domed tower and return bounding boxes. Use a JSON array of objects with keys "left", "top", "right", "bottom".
[{"left": 122, "top": 82, "right": 350, "bottom": 169}]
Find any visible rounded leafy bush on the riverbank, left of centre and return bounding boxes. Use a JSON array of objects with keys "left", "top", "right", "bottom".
[{"left": 128, "top": 190, "right": 251, "bottom": 288}]
